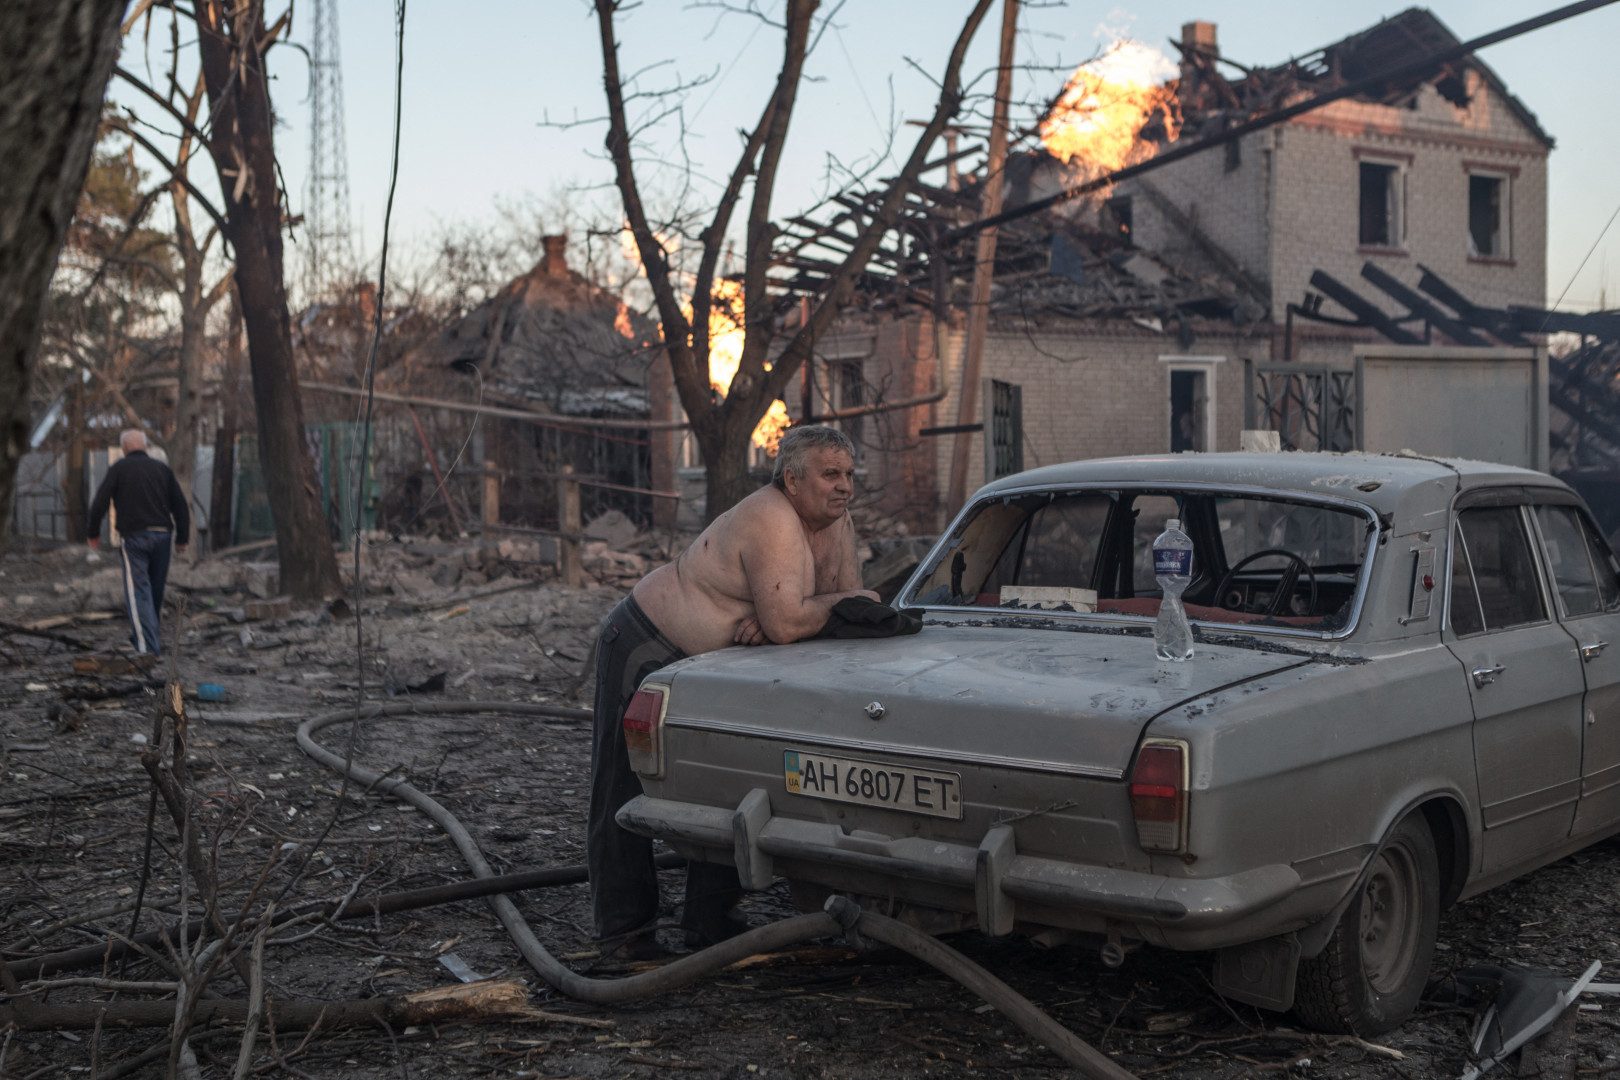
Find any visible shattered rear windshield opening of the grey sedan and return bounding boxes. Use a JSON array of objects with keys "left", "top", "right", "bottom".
[{"left": 910, "top": 489, "right": 1375, "bottom": 631}]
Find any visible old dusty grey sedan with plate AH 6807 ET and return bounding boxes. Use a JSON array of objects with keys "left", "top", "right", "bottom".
[{"left": 619, "top": 453, "right": 1620, "bottom": 1035}]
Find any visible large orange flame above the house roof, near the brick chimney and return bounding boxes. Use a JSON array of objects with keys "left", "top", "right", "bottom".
[{"left": 1040, "top": 39, "right": 1181, "bottom": 175}]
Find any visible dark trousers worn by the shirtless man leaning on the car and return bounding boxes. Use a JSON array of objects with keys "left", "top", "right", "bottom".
[{"left": 585, "top": 596, "right": 740, "bottom": 938}]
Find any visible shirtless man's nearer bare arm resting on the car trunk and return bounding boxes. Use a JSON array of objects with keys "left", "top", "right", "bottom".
[{"left": 732, "top": 500, "right": 870, "bottom": 644}]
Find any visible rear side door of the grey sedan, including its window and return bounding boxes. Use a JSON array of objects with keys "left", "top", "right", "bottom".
[{"left": 1447, "top": 492, "right": 1584, "bottom": 874}]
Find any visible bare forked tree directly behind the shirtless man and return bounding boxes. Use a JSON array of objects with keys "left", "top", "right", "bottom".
[{"left": 596, "top": 0, "right": 991, "bottom": 518}]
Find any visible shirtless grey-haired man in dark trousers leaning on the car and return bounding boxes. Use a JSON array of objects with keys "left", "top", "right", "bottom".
[{"left": 586, "top": 426, "right": 878, "bottom": 946}]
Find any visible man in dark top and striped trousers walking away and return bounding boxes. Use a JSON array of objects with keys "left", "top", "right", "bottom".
[{"left": 89, "top": 429, "right": 191, "bottom": 656}]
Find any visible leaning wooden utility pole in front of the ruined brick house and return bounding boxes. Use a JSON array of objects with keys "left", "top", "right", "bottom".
[{"left": 944, "top": 0, "right": 1019, "bottom": 517}]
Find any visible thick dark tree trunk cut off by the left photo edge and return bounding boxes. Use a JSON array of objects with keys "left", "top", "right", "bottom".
[{"left": 0, "top": 0, "right": 123, "bottom": 549}]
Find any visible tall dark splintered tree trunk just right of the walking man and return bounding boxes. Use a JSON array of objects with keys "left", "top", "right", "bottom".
[{"left": 198, "top": 0, "right": 342, "bottom": 601}]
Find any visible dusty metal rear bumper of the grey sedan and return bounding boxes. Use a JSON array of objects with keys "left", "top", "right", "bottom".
[{"left": 617, "top": 789, "right": 1301, "bottom": 947}]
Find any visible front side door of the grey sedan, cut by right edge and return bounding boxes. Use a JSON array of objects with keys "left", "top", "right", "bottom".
[{"left": 1536, "top": 504, "right": 1620, "bottom": 836}]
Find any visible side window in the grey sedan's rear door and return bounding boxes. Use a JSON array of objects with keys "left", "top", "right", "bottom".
[{"left": 1452, "top": 507, "right": 1547, "bottom": 635}]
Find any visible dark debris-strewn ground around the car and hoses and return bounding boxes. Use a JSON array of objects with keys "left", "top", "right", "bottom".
[{"left": 0, "top": 536, "right": 1620, "bottom": 1080}]
